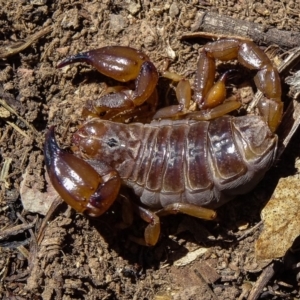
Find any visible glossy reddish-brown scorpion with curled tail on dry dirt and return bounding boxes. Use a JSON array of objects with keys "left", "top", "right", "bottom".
[{"left": 44, "top": 39, "right": 283, "bottom": 246}]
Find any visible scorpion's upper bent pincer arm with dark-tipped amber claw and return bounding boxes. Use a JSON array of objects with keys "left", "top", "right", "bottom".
[{"left": 58, "top": 46, "right": 158, "bottom": 116}]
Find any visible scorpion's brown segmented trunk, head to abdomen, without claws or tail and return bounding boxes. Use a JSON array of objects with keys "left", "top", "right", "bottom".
[{"left": 74, "top": 115, "right": 277, "bottom": 208}]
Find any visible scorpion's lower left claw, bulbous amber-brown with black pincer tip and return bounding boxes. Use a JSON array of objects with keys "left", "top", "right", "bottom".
[{"left": 44, "top": 127, "right": 121, "bottom": 216}]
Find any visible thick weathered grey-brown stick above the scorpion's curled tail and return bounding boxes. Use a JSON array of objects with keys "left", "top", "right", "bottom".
[{"left": 186, "top": 11, "right": 300, "bottom": 49}]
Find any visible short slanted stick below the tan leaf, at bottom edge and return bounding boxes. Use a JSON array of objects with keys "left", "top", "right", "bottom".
[{"left": 247, "top": 261, "right": 281, "bottom": 300}]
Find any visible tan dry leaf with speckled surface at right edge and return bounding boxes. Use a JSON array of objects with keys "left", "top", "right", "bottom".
[{"left": 255, "top": 161, "right": 300, "bottom": 260}]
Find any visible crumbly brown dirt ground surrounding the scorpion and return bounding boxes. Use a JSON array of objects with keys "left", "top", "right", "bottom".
[{"left": 0, "top": 0, "right": 300, "bottom": 300}]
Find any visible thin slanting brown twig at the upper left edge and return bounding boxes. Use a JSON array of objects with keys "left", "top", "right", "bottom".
[{"left": 0, "top": 26, "right": 52, "bottom": 59}]
